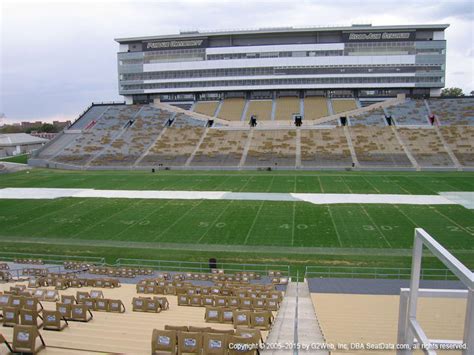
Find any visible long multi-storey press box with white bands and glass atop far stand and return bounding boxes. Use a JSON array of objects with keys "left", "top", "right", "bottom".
[{"left": 116, "top": 24, "right": 449, "bottom": 103}]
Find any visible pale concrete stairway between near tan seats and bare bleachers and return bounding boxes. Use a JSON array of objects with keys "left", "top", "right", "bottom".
[{"left": 262, "top": 282, "right": 329, "bottom": 355}]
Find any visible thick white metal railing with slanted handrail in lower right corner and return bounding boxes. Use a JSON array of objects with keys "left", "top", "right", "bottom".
[{"left": 397, "top": 228, "right": 474, "bottom": 355}]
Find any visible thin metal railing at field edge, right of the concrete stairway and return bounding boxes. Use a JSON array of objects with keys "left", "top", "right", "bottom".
[{"left": 305, "top": 266, "right": 457, "bottom": 280}]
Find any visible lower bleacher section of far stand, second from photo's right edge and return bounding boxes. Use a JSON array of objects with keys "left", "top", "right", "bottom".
[{"left": 398, "top": 128, "right": 454, "bottom": 167}]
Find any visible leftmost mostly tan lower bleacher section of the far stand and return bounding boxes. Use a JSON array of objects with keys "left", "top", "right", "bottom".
[{"left": 140, "top": 127, "right": 204, "bottom": 166}]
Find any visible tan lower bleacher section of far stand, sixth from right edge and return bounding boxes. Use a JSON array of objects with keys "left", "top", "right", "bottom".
[{"left": 191, "top": 129, "right": 249, "bottom": 166}]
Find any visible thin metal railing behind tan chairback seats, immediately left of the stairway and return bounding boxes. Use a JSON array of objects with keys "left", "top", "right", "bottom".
[{"left": 115, "top": 258, "right": 290, "bottom": 277}]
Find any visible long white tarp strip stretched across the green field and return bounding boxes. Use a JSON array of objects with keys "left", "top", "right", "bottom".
[{"left": 0, "top": 188, "right": 462, "bottom": 208}]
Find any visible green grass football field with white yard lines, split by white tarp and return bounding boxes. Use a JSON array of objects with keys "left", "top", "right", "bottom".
[{"left": 0, "top": 169, "right": 474, "bottom": 276}]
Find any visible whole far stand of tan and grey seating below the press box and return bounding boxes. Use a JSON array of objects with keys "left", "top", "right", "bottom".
[{"left": 33, "top": 97, "right": 474, "bottom": 168}]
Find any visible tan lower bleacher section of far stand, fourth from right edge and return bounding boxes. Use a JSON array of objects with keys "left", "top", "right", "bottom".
[{"left": 301, "top": 127, "right": 352, "bottom": 167}]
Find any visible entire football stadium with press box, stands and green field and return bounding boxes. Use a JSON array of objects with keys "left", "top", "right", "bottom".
[{"left": 0, "top": 20, "right": 474, "bottom": 355}]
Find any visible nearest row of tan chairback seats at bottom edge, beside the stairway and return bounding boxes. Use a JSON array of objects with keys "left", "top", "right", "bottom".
[{"left": 151, "top": 326, "right": 262, "bottom": 355}]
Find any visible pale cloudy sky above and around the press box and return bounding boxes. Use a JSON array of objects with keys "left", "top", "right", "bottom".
[{"left": 0, "top": 0, "right": 474, "bottom": 124}]
